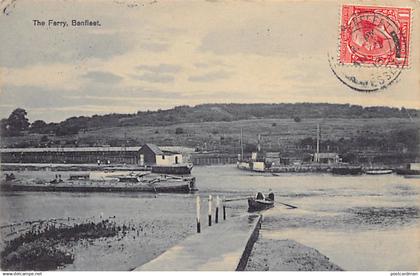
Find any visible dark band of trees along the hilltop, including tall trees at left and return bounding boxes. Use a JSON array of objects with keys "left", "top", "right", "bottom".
[{"left": 0, "top": 103, "right": 420, "bottom": 136}]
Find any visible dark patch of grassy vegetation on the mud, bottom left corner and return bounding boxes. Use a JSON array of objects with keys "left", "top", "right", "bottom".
[{"left": 0, "top": 220, "right": 121, "bottom": 271}]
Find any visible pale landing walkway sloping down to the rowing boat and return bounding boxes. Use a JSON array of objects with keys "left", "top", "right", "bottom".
[{"left": 135, "top": 214, "right": 262, "bottom": 271}]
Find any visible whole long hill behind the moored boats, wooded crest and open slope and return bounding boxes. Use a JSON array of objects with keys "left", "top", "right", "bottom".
[{"left": 2, "top": 104, "right": 420, "bottom": 164}]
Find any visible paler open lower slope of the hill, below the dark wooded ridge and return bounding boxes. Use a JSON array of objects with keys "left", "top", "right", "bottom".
[{"left": 3, "top": 118, "right": 420, "bottom": 160}]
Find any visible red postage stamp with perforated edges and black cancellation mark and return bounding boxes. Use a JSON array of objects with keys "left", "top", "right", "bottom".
[{"left": 340, "top": 5, "right": 411, "bottom": 67}]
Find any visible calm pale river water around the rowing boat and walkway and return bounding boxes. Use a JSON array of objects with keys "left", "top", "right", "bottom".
[{"left": 0, "top": 166, "right": 420, "bottom": 270}]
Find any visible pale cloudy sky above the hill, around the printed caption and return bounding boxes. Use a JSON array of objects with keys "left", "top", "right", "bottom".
[{"left": 0, "top": 0, "right": 420, "bottom": 121}]
